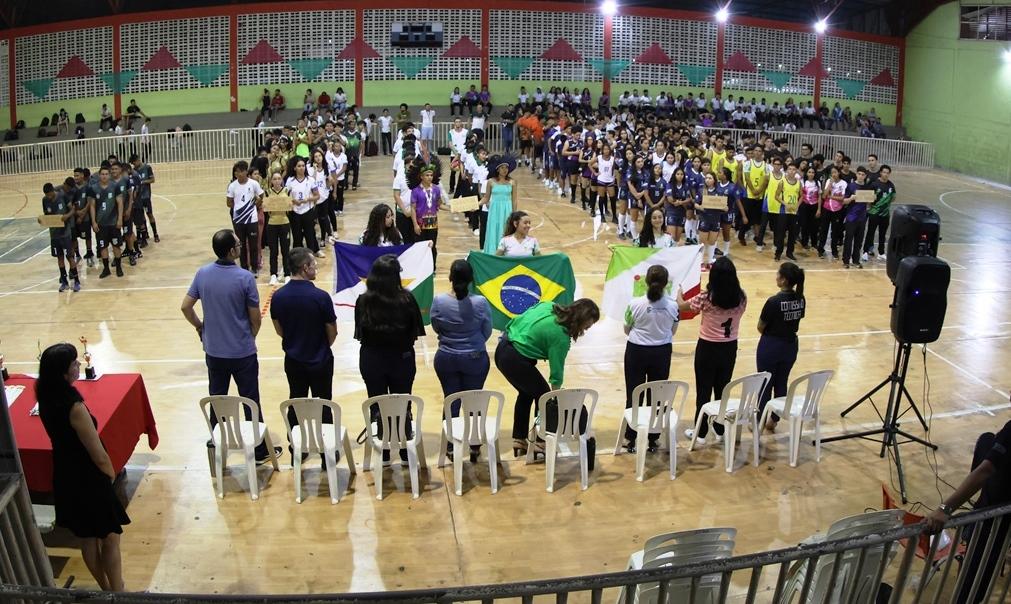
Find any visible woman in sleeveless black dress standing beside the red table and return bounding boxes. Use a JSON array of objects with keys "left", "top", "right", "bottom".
[{"left": 35, "top": 344, "right": 129, "bottom": 592}]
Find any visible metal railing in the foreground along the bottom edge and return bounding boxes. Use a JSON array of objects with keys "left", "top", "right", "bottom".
[{"left": 0, "top": 505, "right": 1011, "bottom": 604}]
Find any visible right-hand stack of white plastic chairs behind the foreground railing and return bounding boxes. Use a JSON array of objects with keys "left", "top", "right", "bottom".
[{"left": 779, "top": 510, "right": 915, "bottom": 604}]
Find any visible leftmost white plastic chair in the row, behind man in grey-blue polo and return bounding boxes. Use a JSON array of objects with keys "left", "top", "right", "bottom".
[{"left": 200, "top": 395, "right": 279, "bottom": 501}]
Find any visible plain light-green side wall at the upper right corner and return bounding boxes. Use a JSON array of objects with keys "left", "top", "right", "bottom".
[{"left": 903, "top": 2, "right": 1011, "bottom": 183}]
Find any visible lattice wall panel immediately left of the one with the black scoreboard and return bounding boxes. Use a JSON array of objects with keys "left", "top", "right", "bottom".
[{"left": 238, "top": 10, "right": 355, "bottom": 86}]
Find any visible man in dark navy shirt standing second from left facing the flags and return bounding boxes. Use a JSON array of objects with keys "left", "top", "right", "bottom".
[{"left": 270, "top": 248, "right": 337, "bottom": 457}]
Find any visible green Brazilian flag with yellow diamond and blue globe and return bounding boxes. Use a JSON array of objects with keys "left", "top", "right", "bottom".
[{"left": 467, "top": 252, "right": 575, "bottom": 330}]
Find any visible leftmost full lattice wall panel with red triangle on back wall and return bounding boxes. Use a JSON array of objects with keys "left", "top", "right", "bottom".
[{"left": 14, "top": 27, "right": 112, "bottom": 105}]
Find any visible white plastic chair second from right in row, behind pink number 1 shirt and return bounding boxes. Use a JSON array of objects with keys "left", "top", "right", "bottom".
[{"left": 688, "top": 371, "right": 771, "bottom": 472}]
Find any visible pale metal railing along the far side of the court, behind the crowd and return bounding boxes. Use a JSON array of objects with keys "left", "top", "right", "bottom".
[{"left": 0, "top": 121, "right": 934, "bottom": 175}]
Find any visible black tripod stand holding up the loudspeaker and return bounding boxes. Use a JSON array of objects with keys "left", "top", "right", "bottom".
[{"left": 822, "top": 343, "right": 937, "bottom": 503}]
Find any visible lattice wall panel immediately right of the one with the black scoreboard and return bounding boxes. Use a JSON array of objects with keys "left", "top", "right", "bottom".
[{"left": 488, "top": 10, "right": 604, "bottom": 82}]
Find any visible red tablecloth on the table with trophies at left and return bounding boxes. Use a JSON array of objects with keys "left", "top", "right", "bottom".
[{"left": 6, "top": 373, "right": 158, "bottom": 493}]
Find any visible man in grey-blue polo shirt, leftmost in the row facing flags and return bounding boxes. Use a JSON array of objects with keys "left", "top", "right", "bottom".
[{"left": 181, "top": 229, "right": 281, "bottom": 463}]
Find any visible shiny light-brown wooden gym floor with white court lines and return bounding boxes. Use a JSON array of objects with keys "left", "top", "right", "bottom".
[{"left": 0, "top": 152, "right": 1011, "bottom": 594}]
